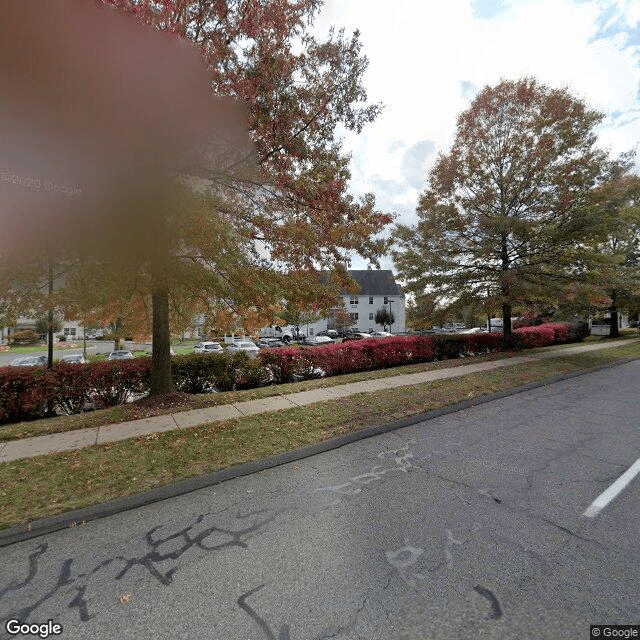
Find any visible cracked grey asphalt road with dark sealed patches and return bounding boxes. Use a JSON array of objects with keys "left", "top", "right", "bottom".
[{"left": 0, "top": 361, "right": 640, "bottom": 640}]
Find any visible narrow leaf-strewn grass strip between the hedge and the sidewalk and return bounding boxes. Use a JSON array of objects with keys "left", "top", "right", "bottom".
[{"left": 0, "top": 338, "right": 637, "bottom": 442}]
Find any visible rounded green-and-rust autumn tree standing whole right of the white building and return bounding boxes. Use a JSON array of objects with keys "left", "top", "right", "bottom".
[{"left": 393, "top": 78, "right": 606, "bottom": 342}]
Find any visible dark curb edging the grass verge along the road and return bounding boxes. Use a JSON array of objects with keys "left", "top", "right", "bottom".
[{"left": 0, "top": 357, "right": 640, "bottom": 547}]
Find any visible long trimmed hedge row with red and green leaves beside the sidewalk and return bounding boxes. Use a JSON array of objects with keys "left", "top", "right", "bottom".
[{"left": 0, "top": 323, "right": 585, "bottom": 424}]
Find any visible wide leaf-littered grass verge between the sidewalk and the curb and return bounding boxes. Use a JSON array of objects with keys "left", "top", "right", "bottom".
[{"left": 0, "top": 343, "right": 640, "bottom": 528}]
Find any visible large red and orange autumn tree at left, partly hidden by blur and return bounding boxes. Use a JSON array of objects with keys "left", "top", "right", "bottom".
[{"left": 1, "top": 0, "right": 392, "bottom": 393}]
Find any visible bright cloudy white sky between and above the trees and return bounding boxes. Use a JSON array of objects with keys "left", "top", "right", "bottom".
[{"left": 316, "top": 0, "right": 640, "bottom": 269}]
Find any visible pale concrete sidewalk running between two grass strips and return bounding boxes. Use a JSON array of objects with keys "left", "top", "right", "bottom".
[{"left": 0, "top": 338, "right": 640, "bottom": 463}]
